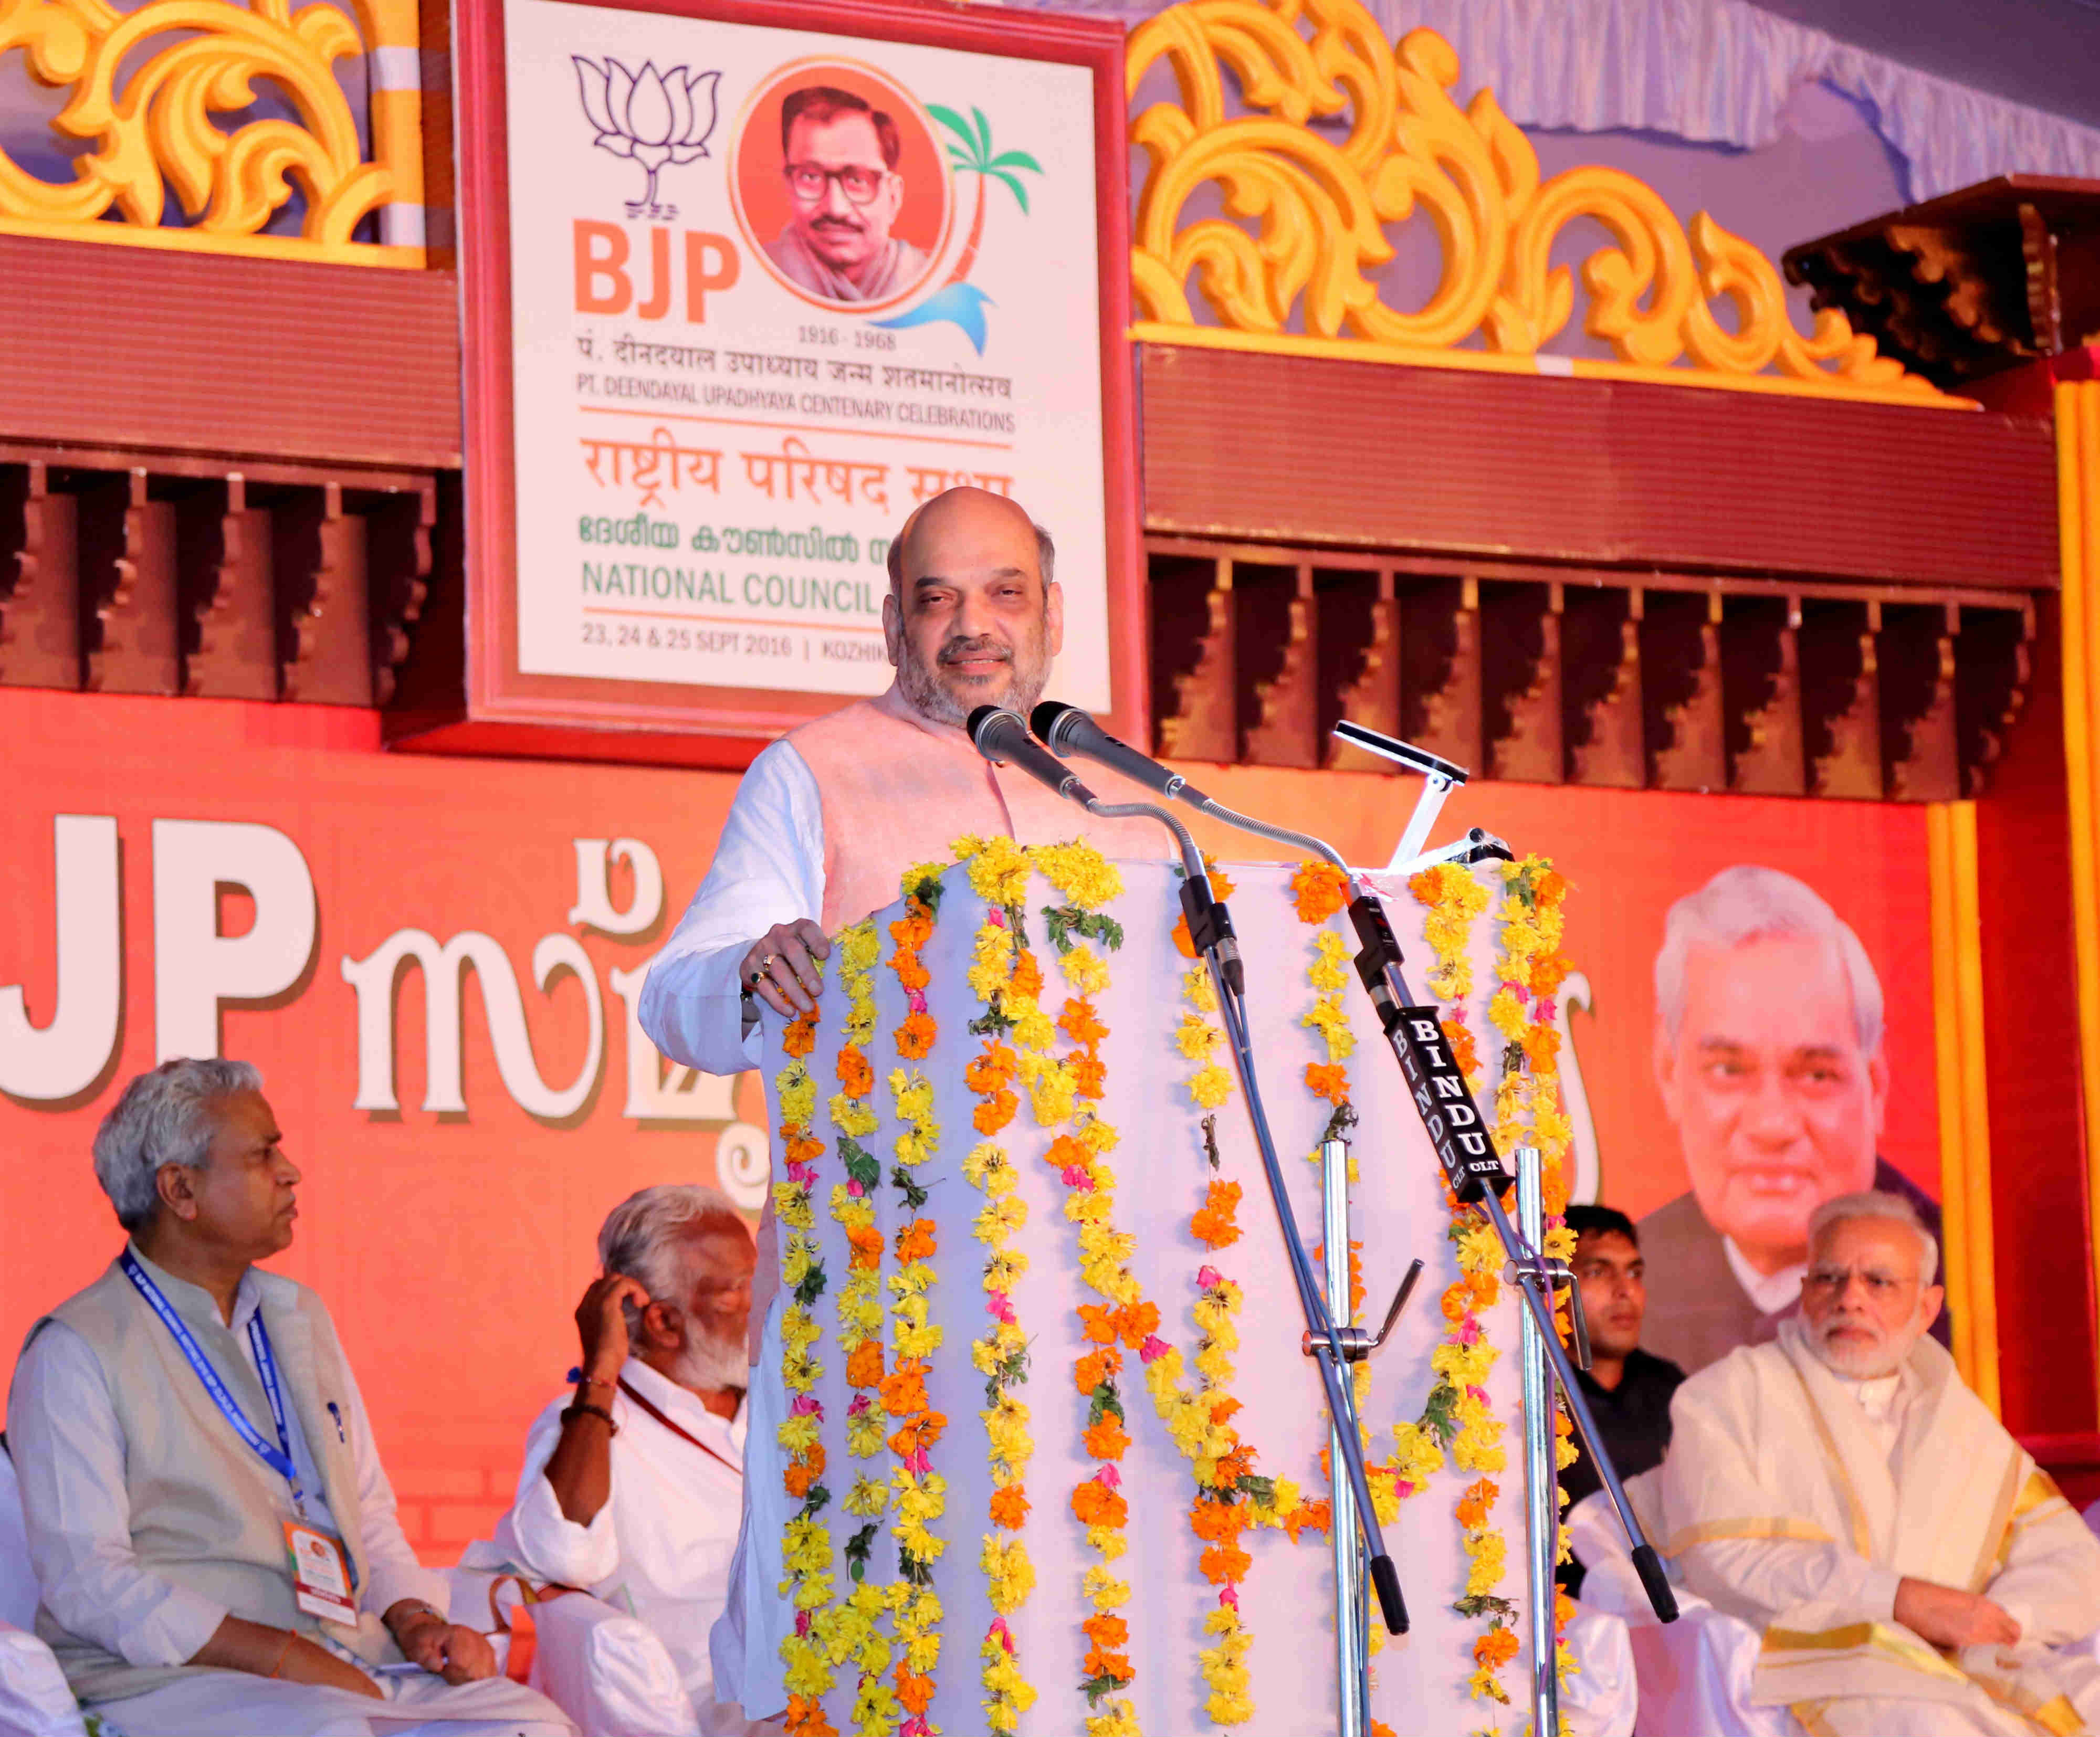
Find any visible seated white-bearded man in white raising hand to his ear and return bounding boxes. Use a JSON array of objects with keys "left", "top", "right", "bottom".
[{"left": 496, "top": 1185, "right": 756, "bottom": 1737}]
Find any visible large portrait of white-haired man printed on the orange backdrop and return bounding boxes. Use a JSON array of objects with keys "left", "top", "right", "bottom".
[{"left": 1640, "top": 863, "right": 1951, "bottom": 1374}]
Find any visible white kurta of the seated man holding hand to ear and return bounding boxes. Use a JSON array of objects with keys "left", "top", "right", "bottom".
[{"left": 496, "top": 1357, "right": 748, "bottom": 1729}]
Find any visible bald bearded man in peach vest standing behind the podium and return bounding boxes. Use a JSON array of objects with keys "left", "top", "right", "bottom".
[{"left": 640, "top": 489, "right": 1172, "bottom": 1718}]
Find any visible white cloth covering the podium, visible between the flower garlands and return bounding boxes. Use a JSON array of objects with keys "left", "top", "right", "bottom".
[{"left": 735, "top": 861, "right": 1562, "bottom": 1737}]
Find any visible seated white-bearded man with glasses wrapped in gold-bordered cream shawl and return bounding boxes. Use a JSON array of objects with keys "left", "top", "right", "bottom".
[{"left": 1653, "top": 1193, "right": 2100, "bottom": 1737}]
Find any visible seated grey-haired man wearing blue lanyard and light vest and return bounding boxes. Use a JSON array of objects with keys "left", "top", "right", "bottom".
[{"left": 8, "top": 1061, "right": 571, "bottom": 1737}]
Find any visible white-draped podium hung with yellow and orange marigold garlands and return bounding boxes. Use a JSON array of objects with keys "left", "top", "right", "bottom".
[{"left": 743, "top": 840, "right": 1562, "bottom": 1737}]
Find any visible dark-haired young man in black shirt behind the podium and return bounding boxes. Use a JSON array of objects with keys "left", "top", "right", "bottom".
[{"left": 1560, "top": 1206, "right": 1684, "bottom": 1596}]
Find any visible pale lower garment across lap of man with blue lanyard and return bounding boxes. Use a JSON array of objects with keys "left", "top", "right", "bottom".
[{"left": 88, "top": 1670, "right": 575, "bottom": 1737}]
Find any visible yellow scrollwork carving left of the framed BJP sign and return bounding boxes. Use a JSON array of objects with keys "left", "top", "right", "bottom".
[{"left": 0, "top": 0, "right": 424, "bottom": 267}]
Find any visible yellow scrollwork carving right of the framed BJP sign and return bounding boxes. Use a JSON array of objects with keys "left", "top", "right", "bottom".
[{"left": 1128, "top": 0, "right": 1966, "bottom": 407}]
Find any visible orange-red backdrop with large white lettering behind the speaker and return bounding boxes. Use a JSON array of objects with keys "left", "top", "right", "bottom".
[{"left": 0, "top": 691, "right": 1938, "bottom": 1561}]
